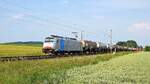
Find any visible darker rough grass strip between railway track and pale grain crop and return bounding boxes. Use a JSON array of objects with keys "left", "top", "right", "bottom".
[{"left": 0, "top": 52, "right": 129, "bottom": 84}]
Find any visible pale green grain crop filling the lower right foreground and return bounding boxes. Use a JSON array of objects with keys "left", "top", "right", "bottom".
[{"left": 64, "top": 52, "right": 150, "bottom": 84}]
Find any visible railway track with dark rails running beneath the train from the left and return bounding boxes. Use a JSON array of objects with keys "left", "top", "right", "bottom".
[{"left": 0, "top": 53, "right": 94, "bottom": 62}]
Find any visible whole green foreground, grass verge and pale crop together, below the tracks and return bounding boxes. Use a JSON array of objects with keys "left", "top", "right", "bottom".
[{"left": 0, "top": 52, "right": 150, "bottom": 84}]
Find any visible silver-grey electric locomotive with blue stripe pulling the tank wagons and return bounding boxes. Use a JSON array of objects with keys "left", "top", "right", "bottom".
[{"left": 43, "top": 35, "right": 83, "bottom": 54}]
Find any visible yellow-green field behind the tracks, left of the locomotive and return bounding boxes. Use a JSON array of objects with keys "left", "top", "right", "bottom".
[{"left": 0, "top": 44, "right": 43, "bottom": 56}]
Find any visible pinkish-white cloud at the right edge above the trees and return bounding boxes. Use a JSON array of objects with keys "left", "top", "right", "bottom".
[{"left": 128, "top": 22, "right": 150, "bottom": 33}]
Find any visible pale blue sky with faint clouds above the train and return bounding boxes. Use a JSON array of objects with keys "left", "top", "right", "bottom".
[{"left": 0, "top": 0, "right": 150, "bottom": 45}]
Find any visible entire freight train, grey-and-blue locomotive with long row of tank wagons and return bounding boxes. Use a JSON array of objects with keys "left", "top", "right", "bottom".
[{"left": 42, "top": 35, "right": 141, "bottom": 55}]
